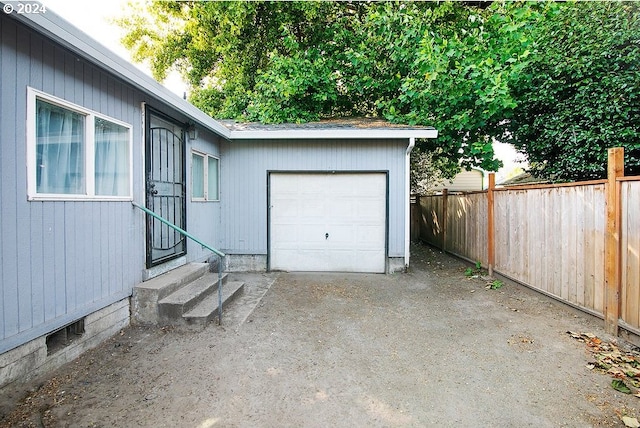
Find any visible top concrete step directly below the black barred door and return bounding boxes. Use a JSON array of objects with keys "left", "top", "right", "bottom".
[{"left": 133, "top": 263, "right": 210, "bottom": 324}]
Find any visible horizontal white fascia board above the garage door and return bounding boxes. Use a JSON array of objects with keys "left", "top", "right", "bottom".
[{"left": 230, "top": 128, "right": 438, "bottom": 140}]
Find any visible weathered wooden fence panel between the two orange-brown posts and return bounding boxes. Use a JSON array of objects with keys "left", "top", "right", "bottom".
[{"left": 496, "top": 184, "right": 604, "bottom": 313}]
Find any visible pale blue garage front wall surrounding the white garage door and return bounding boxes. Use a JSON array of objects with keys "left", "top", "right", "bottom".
[{"left": 219, "top": 140, "right": 408, "bottom": 270}]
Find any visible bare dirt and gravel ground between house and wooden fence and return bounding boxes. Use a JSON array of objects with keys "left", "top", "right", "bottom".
[{"left": 0, "top": 242, "right": 640, "bottom": 428}]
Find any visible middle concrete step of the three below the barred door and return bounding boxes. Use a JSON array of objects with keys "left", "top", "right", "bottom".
[{"left": 158, "top": 272, "right": 227, "bottom": 324}]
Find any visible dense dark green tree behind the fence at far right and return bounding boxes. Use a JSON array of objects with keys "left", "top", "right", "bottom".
[{"left": 502, "top": 2, "right": 640, "bottom": 181}]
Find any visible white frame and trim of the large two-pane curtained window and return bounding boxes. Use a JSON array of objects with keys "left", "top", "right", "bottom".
[{"left": 26, "top": 87, "right": 133, "bottom": 201}]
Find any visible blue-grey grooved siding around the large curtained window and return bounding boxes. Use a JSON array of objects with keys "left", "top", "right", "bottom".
[{"left": 0, "top": 16, "right": 144, "bottom": 352}]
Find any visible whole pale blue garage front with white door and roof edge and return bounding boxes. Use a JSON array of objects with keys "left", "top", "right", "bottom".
[{"left": 220, "top": 120, "right": 437, "bottom": 273}]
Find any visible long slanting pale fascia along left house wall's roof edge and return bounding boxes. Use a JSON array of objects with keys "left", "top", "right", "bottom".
[{"left": 7, "top": 1, "right": 229, "bottom": 139}]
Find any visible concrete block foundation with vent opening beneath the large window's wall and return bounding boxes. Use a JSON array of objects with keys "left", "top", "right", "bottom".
[{"left": 0, "top": 298, "right": 130, "bottom": 389}]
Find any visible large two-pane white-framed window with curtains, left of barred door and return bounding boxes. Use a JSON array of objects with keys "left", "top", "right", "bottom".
[{"left": 27, "top": 88, "right": 132, "bottom": 200}]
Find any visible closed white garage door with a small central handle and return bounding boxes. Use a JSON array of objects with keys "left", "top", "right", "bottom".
[{"left": 269, "top": 173, "right": 387, "bottom": 273}]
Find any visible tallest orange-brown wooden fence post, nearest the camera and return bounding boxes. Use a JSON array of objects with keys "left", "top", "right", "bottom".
[{"left": 604, "top": 147, "right": 624, "bottom": 336}]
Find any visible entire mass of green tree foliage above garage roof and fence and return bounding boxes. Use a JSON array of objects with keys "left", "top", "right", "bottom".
[{"left": 120, "top": 0, "right": 640, "bottom": 182}]
